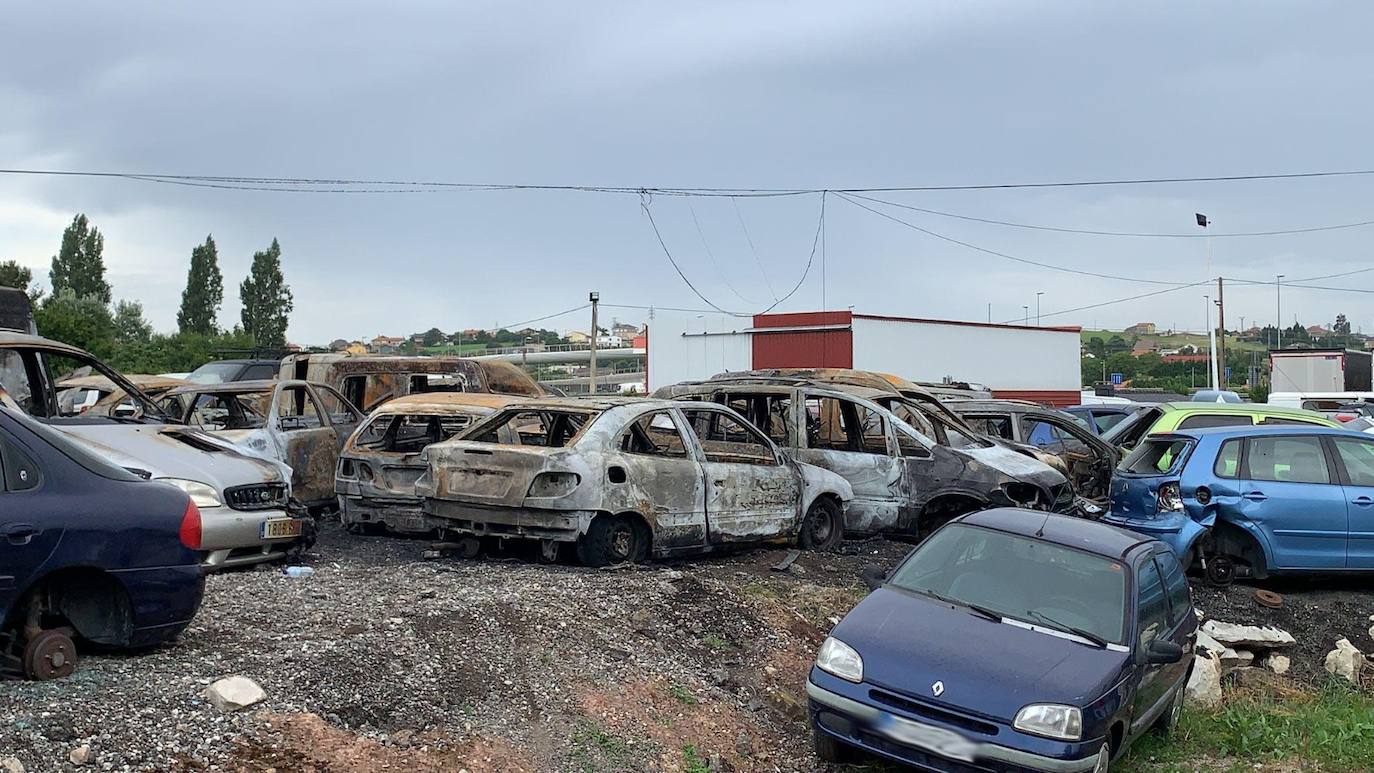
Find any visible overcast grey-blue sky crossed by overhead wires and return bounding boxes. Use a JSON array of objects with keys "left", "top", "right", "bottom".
[{"left": 0, "top": 0, "right": 1374, "bottom": 343}]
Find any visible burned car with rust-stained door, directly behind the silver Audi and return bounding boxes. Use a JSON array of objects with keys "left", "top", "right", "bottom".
[{"left": 165, "top": 380, "right": 363, "bottom": 508}]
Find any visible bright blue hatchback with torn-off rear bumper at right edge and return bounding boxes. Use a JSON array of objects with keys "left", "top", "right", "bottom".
[{"left": 1103, "top": 424, "right": 1374, "bottom": 584}]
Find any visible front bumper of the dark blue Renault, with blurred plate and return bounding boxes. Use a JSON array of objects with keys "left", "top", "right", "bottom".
[{"left": 807, "top": 680, "right": 1101, "bottom": 773}]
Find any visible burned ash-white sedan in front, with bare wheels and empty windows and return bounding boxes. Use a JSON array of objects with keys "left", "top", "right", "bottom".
[{"left": 415, "top": 398, "right": 852, "bottom": 566}]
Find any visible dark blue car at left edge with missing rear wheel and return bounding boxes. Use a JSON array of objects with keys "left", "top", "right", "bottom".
[{"left": 0, "top": 408, "right": 205, "bottom": 680}]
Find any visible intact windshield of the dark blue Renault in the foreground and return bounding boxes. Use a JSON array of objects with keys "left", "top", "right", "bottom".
[{"left": 888, "top": 523, "right": 1125, "bottom": 644}]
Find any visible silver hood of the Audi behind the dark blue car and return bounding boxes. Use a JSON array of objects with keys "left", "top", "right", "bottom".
[{"left": 52, "top": 424, "right": 291, "bottom": 490}]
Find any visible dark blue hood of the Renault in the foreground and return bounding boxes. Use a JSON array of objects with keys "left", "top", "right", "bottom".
[{"left": 831, "top": 588, "right": 1128, "bottom": 722}]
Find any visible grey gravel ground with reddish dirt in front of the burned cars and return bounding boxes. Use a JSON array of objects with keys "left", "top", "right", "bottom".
[{"left": 0, "top": 524, "right": 908, "bottom": 773}]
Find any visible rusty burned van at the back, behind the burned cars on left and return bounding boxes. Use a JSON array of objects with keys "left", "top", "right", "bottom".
[{"left": 278, "top": 354, "right": 547, "bottom": 413}]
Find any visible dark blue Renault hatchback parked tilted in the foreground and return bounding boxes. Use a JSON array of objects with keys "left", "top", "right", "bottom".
[{"left": 807, "top": 508, "right": 1197, "bottom": 772}]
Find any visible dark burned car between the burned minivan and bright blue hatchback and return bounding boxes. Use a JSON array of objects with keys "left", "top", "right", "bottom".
[{"left": 945, "top": 400, "right": 1121, "bottom": 515}]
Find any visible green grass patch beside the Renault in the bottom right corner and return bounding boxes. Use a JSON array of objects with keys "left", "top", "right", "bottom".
[{"left": 1120, "top": 682, "right": 1374, "bottom": 772}]
